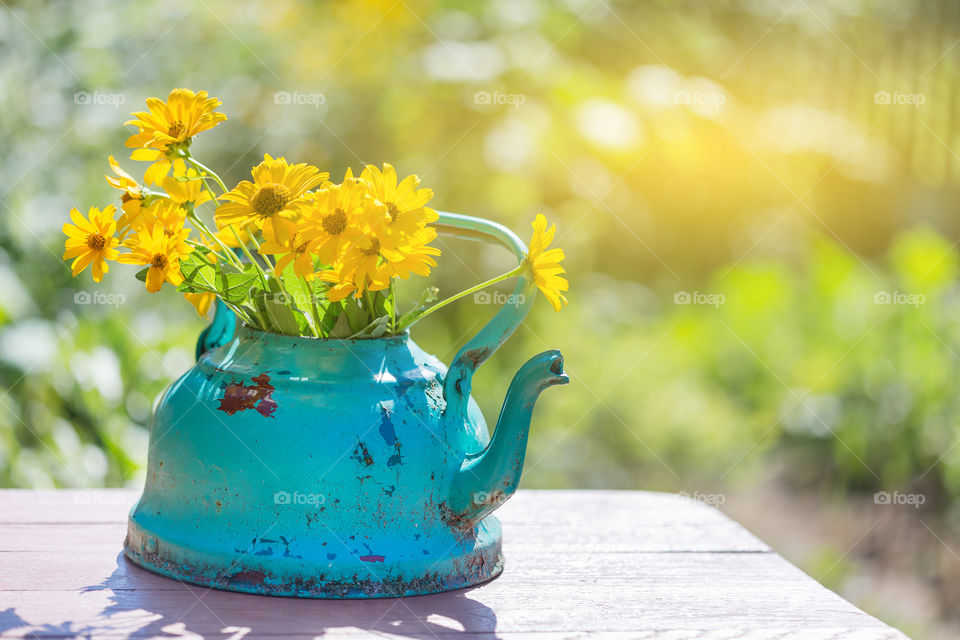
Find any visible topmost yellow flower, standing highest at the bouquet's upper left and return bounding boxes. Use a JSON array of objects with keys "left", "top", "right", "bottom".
[{"left": 124, "top": 89, "right": 227, "bottom": 184}]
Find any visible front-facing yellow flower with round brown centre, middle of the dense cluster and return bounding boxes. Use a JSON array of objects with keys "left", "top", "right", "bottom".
[{"left": 298, "top": 169, "right": 376, "bottom": 265}]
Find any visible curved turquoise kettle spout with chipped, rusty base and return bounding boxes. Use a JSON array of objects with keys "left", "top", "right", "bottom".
[{"left": 450, "top": 350, "right": 570, "bottom": 522}]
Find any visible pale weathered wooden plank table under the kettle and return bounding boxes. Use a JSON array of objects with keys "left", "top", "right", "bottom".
[{"left": 0, "top": 490, "right": 905, "bottom": 640}]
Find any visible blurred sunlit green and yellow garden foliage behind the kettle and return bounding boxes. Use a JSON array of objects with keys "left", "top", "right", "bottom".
[{"left": 0, "top": 0, "right": 960, "bottom": 524}]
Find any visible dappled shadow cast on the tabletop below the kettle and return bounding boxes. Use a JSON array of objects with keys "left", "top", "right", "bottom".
[{"left": 61, "top": 553, "right": 497, "bottom": 638}]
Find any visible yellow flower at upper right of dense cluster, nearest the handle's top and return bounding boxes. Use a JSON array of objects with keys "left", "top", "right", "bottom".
[{"left": 360, "top": 163, "right": 438, "bottom": 248}]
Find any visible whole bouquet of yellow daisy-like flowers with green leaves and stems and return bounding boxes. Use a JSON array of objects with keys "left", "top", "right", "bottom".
[{"left": 63, "top": 89, "right": 568, "bottom": 338}]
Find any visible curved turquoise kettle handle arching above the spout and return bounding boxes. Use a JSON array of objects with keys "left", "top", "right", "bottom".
[{"left": 433, "top": 211, "right": 537, "bottom": 424}]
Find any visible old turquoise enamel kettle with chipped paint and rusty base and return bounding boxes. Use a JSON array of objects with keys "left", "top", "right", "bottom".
[{"left": 124, "top": 213, "right": 568, "bottom": 598}]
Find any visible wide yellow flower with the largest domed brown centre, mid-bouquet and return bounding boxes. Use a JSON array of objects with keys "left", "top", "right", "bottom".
[{"left": 215, "top": 155, "right": 330, "bottom": 234}]
